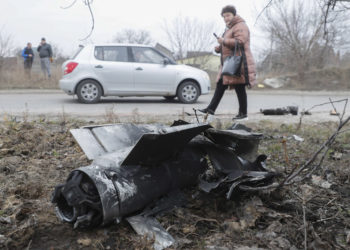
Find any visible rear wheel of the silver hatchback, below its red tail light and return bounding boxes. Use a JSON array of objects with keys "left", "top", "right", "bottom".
[{"left": 77, "top": 79, "right": 102, "bottom": 104}]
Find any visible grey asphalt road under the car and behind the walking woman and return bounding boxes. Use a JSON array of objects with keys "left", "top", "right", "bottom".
[{"left": 0, "top": 90, "right": 350, "bottom": 122}]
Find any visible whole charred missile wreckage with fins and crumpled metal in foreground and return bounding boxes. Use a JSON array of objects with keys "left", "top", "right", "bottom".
[{"left": 52, "top": 121, "right": 275, "bottom": 249}]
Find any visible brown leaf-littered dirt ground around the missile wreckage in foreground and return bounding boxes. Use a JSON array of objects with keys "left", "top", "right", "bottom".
[{"left": 0, "top": 117, "right": 350, "bottom": 249}]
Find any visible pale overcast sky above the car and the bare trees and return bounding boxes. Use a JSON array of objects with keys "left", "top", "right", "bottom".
[{"left": 0, "top": 0, "right": 268, "bottom": 55}]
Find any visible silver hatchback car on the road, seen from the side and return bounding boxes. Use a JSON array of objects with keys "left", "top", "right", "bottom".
[{"left": 59, "top": 44, "right": 210, "bottom": 103}]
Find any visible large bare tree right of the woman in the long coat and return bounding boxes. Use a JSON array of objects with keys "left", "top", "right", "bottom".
[{"left": 261, "top": 0, "right": 347, "bottom": 81}]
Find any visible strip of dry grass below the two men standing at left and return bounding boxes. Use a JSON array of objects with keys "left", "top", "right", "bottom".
[{"left": 0, "top": 65, "right": 62, "bottom": 89}]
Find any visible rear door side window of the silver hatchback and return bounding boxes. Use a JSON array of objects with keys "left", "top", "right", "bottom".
[{"left": 94, "top": 46, "right": 128, "bottom": 62}]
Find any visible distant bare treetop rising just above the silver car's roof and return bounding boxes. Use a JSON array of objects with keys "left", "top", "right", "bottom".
[{"left": 112, "top": 29, "right": 153, "bottom": 44}]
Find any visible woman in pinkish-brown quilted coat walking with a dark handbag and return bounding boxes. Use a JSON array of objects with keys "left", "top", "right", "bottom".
[{"left": 199, "top": 5, "right": 256, "bottom": 120}]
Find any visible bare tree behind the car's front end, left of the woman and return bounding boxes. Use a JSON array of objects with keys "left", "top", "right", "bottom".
[{"left": 162, "top": 16, "right": 217, "bottom": 65}]
